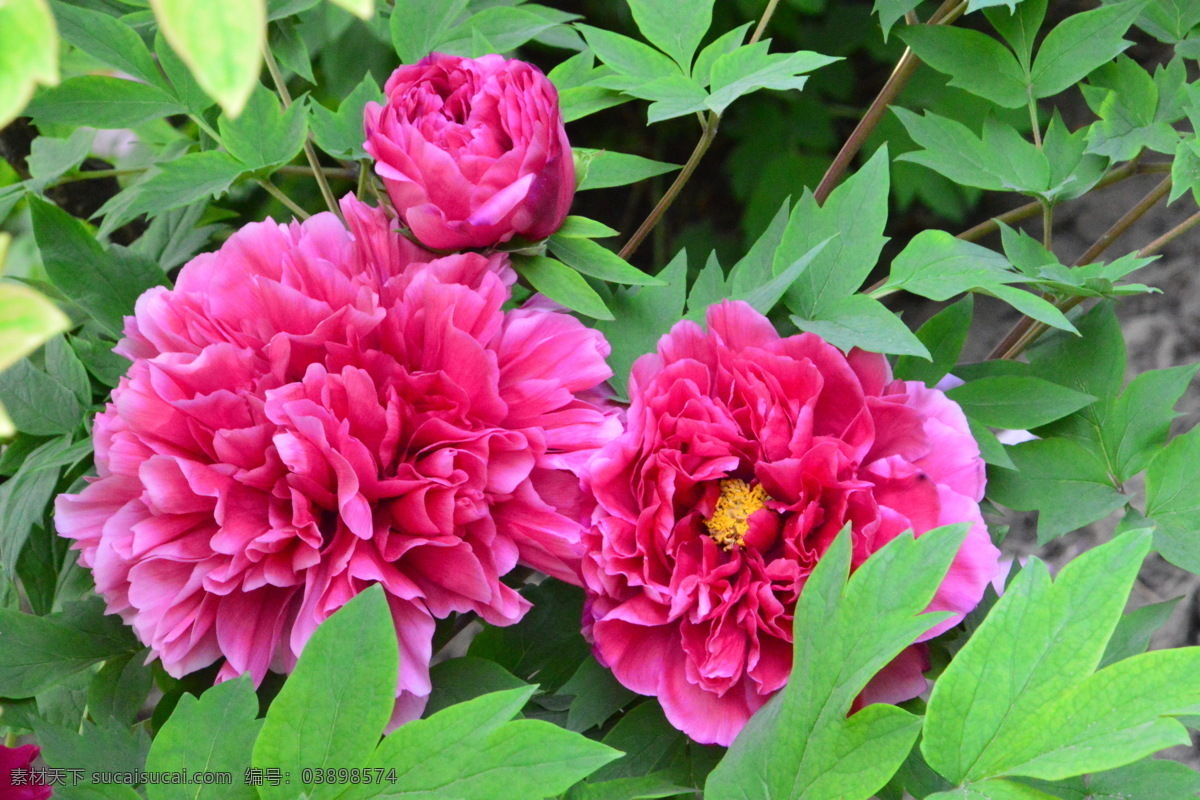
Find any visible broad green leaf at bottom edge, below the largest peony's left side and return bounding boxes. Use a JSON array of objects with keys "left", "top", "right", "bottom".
[{"left": 146, "top": 675, "right": 261, "bottom": 800}]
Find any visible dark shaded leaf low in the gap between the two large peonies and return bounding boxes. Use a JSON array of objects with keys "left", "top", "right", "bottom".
[{"left": 467, "top": 575, "right": 595, "bottom": 692}]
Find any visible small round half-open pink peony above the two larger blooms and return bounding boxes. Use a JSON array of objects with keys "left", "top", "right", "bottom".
[{"left": 365, "top": 53, "right": 575, "bottom": 249}]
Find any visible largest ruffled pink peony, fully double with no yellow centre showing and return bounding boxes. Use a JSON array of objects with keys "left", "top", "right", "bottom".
[{"left": 56, "top": 197, "right": 619, "bottom": 721}]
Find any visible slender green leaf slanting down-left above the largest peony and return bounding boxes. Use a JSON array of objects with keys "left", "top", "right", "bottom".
[{"left": 98, "top": 150, "right": 246, "bottom": 230}]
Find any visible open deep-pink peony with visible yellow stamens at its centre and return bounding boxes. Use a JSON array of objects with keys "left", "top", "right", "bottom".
[{"left": 582, "top": 301, "right": 998, "bottom": 745}]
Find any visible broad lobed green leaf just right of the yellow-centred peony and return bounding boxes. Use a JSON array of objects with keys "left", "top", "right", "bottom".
[{"left": 988, "top": 438, "right": 1128, "bottom": 543}]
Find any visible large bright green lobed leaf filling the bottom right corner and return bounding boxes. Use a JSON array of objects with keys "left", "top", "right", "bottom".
[{"left": 922, "top": 531, "right": 1200, "bottom": 796}]
